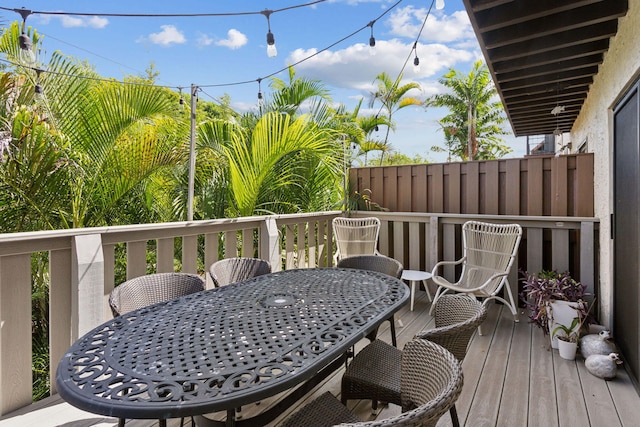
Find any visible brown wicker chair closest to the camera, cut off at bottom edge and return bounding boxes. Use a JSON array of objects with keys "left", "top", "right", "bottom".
[{"left": 283, "top": 339, "right": 463, "bottom": 427}]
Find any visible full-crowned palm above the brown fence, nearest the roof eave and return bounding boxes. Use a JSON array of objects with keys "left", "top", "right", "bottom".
[{"left": 425, "top": 61, "right": 510, "bottom": 160}]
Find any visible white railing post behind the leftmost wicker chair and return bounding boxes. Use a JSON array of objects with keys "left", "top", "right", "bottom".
[{"left": 71, "top": 234, "right": 104, "bottom": 340}]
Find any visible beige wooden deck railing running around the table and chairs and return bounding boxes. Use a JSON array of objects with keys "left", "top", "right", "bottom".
[{"left": 0, "top": 211, "right": 598, "bottom": 415}]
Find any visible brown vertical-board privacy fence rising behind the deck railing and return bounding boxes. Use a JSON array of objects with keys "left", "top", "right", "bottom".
[{"left": 349, "top": 153, "right": 594, "bottom": 217}]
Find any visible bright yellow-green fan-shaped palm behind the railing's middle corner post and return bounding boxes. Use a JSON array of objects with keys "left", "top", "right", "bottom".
[{"left": 223, "top": 112, "right": 340, "bottom": 216}]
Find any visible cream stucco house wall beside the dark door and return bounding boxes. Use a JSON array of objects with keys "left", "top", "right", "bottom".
[{"left": 571, "top": 0, "right": 640, "bottom": 327}]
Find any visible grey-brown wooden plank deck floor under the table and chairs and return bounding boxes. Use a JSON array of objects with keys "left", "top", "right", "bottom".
[{"left": 0, "top": 292, "right": 640, "bottom": 427}]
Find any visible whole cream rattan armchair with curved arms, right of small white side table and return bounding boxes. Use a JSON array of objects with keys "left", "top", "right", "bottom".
[{"left": 430, "top": 221, "right": 522, "bottom": 322}]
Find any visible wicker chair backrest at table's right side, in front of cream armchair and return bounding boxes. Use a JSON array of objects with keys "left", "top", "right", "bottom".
[{"left": 416, "top": 294, "right": 487, "bottom": 362}]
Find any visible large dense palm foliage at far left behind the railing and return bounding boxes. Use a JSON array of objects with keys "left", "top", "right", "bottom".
[{"left": 0, "top": 23, "right": 187, "bottom": 231}]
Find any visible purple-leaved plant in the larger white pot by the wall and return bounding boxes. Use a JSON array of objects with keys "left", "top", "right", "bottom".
[{"left": 521, "top": 270, "right": 589, "bottom": 348}]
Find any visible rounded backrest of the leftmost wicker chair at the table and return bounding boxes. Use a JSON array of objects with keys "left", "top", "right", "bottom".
[{"left": 109, "top": 273, "right": 205, "bottom": 317}]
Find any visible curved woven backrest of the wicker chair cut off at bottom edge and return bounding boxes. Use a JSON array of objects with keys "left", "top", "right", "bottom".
[{"left": 340, "top": 339, "right": 463, "bottom": 427}]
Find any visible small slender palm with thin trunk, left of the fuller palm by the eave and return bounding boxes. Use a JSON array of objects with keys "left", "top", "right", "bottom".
[{"left": 369, "top": 72, "right": 422, "bottom": 164}]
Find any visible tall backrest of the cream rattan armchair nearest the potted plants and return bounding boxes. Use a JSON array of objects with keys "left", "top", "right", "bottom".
[{"left": 460, "top": 221, "right": 522, "bottom": 294}]
